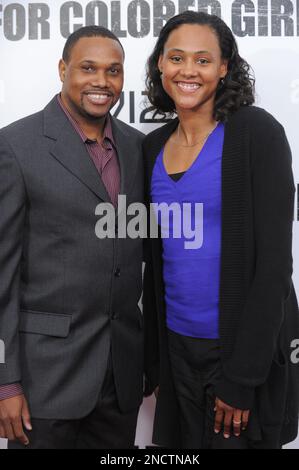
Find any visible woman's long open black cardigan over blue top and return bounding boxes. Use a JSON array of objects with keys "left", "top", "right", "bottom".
[{"left": 143, "top": 106, "right": 299, "bottom": 447}]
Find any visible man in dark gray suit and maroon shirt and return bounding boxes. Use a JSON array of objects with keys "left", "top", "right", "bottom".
[{"left": 0, "top": 26, "right": 143, "bottom": 449}]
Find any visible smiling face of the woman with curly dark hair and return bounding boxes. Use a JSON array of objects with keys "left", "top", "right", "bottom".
[{"left": 158, "top": 24, "right": 227, "bottom": 113}]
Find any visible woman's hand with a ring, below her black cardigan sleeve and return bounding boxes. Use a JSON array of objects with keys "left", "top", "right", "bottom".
[{"left": 214, "top": 398, "right": 250, "bottom": 439}]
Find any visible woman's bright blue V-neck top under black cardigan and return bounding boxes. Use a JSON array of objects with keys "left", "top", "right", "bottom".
[{"left": 151, "top": 123, "right": 224, "bottom": 339}]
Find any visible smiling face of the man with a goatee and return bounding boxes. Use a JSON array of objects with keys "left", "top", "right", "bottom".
[{"left": 59, "top": 37, "right": 124, "bottom": 121}]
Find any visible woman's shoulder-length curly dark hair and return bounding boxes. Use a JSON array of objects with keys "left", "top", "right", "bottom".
[{"left": 146, "top": 11, "right": 255, "bottom": 121}]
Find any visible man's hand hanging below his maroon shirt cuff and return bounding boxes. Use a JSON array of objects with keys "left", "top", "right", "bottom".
[{"left": 0, "top": 395, "right": 32, "bottom": 446}]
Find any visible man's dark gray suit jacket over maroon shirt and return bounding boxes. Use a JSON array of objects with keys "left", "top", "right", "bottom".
[{"left": 0, "top": 97, "right": 143, "bottom": 419}]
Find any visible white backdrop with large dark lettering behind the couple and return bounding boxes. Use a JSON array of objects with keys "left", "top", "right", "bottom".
[{"left": 0, "top": 0, "right": 299, "bottom": 448}]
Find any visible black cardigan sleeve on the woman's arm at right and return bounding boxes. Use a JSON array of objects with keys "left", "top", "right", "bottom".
[{"left": 216, "top": 120, "right": 295, "bottom": 409}]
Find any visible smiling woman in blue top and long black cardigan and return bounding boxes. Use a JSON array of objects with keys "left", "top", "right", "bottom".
[{"left": 143, "top": 11, "right": 299, "bottom": 449}]
